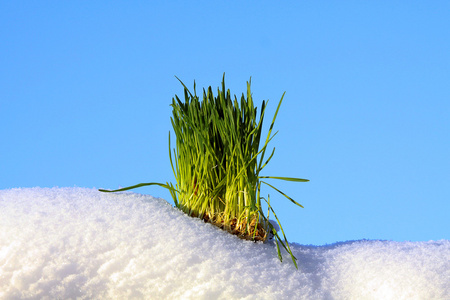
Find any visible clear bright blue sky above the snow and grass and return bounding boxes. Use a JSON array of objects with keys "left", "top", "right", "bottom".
[{"left": 0, "top": 1, "right": 450, "bottom": 245}]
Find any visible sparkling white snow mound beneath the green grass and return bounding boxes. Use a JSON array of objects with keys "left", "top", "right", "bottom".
[{"left": 0, "top": 188, "right": 450, "bottom": 299}]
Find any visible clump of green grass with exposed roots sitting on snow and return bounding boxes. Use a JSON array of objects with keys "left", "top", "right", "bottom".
[{"left": 101, "top": 75, "right": 308, "bottom": 267}]
